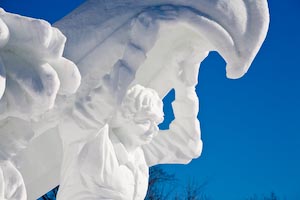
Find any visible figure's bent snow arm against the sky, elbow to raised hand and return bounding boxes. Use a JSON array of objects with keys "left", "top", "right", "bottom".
[{"left": 143, "top": 50, "right": 202, "bottom": 166}]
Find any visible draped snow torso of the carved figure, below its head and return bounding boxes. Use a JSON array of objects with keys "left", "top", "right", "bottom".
[{"left": 57, "top": 126, "right": 148, "bottom": 200}]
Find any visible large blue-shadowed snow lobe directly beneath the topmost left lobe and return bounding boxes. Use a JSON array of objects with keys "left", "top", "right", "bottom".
[{"left": 2, "top": 52, "right": 60, "bottom": 118}]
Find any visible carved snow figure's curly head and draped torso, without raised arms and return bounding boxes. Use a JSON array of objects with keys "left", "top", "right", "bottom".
[{"left": 58, "top": 85, "right": 166, "bottom": 200}]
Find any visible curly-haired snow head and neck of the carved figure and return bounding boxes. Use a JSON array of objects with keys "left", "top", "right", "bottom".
[{"left": 111, "top": 85, "right": 164, "bottom": 149}]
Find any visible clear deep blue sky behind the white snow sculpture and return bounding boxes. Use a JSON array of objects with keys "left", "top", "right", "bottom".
[{"left": 0, "top": 0, "right": 300, "bottom": 200}]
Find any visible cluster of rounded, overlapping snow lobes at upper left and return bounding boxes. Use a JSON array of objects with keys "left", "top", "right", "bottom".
[{"left": 0, "top": 8, "right": 81, "bottom": 118}]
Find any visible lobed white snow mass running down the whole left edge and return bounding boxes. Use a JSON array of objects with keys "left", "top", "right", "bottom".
[{"left": 0, "top": 8, "right": 81, "bottom": 200}]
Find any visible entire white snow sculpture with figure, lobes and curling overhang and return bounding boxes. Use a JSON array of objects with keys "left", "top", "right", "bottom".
[{"left": 0, "top": 0, "right": 269, "bottom": 200}]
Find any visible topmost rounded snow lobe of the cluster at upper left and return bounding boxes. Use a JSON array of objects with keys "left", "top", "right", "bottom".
[{"left": 0, "top": 12, "right": 66, "bottom": 59}]
